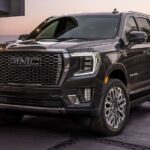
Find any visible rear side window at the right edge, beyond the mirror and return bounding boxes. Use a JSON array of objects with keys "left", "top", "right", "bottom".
[{"left": 137, "top": 18, "right": 150, "bottom": 42}]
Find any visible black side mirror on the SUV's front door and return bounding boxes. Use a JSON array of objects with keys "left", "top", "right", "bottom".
[{"left": 129, "top": 31, "right": 148, "bottom": 44}]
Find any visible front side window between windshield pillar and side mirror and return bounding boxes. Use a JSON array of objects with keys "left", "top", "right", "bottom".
[{"left": 124, "top": 17, "right": 138, "bottom": 42}]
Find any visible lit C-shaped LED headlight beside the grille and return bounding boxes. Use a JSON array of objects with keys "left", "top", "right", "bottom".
[{"left": 71, "top": 52, "right": 101, "bottom": 76}]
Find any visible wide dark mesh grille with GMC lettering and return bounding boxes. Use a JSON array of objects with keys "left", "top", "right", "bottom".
[{"left": 0, "top": 51, "right": 63, "bottom": 86}]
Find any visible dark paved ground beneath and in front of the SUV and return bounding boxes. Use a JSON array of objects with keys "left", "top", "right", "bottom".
[{"left": 0, "top": 102, "right": 150, "bottom": 150}]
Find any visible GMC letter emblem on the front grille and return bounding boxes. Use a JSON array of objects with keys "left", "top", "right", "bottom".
[{"left": 10, "top": 57, "right": 41, "bottom": 66}]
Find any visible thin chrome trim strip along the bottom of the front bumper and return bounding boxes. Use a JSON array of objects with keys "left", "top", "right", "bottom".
[{"left": 0, "top": 103, "right": 66, "bottom": 113}]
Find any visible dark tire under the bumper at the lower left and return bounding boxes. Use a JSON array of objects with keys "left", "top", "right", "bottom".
[{"left": 0, "top": 111, "right": 24, "bottom": 125}]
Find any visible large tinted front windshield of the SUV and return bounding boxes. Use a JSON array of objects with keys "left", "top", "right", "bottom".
[{"left": 37, "top": 15, "right": 120, "bottom": 40}]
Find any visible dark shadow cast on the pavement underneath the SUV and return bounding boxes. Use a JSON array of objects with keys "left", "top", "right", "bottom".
[{"left": 0, "top": 102, "right": 150, "bottom": 137}]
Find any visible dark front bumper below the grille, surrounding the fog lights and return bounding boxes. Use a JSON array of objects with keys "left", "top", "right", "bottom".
[{"left": 0, "top": 77, "right": 103, "bottom": 116}]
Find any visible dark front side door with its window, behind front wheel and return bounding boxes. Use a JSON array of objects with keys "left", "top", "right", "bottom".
[{"left": 122, "top": 16, "right": 149, "bottom": 93}]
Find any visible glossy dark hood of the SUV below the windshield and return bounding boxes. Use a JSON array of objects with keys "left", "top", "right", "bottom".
[{"left": 7, "top": 39, "right": 117, "bottom": 51}]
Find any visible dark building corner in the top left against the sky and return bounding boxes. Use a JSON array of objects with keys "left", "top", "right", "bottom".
[{"left": 0, "top": 0, "right": 25, "bottom": 17}]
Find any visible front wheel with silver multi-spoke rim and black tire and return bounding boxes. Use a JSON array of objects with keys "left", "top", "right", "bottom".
[{"left": 91, "top": 79, "right": 130, "bottom": 136}]
